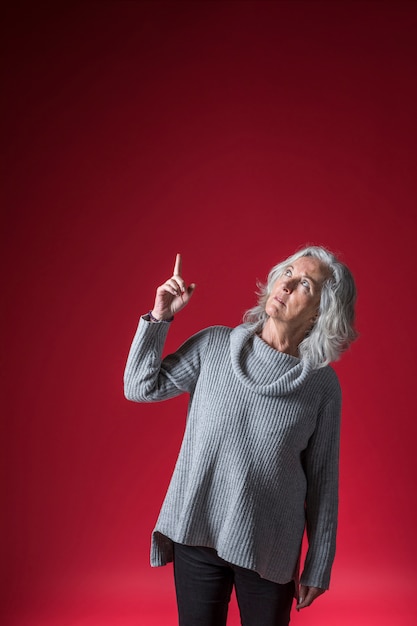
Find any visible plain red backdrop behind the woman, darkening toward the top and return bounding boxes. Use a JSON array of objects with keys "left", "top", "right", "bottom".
[{"left": 1, "top": 1, "right": 417, "bottom": 626}]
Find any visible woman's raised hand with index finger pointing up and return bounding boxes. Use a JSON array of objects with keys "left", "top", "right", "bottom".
[{"left": 152, "top": 254, "right": 195, "bottom": 320}]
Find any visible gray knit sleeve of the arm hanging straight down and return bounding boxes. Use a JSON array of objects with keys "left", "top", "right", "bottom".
[{"left": 301, "top": 380, "right": 341, "bottom": 589}]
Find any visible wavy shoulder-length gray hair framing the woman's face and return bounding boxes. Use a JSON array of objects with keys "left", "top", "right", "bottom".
[{"left": 244, "top": 246, "right": 357, "bottom": 369}]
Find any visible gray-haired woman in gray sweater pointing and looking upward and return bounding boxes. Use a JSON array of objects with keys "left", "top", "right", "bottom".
[{"left": 125, "top": 246, "right": 356, "bottom": 626}]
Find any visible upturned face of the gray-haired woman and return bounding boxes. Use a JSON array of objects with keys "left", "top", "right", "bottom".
[{"left": 265, "top": 257, "right": 329, "bottom": 332}]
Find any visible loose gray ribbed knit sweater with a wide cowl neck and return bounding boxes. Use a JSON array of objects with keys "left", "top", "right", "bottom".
[{"left": 125, "top": 316, "right": 341, "bottom": 588}]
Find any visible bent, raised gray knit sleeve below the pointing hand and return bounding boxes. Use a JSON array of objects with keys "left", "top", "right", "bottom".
[{"left": 124, "top": 317, "right": 208, "bottom": 402}]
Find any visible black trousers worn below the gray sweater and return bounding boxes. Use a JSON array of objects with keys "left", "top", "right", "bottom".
[{"left": 174, "top": 543, "right": 294, "bottom": 626}]
